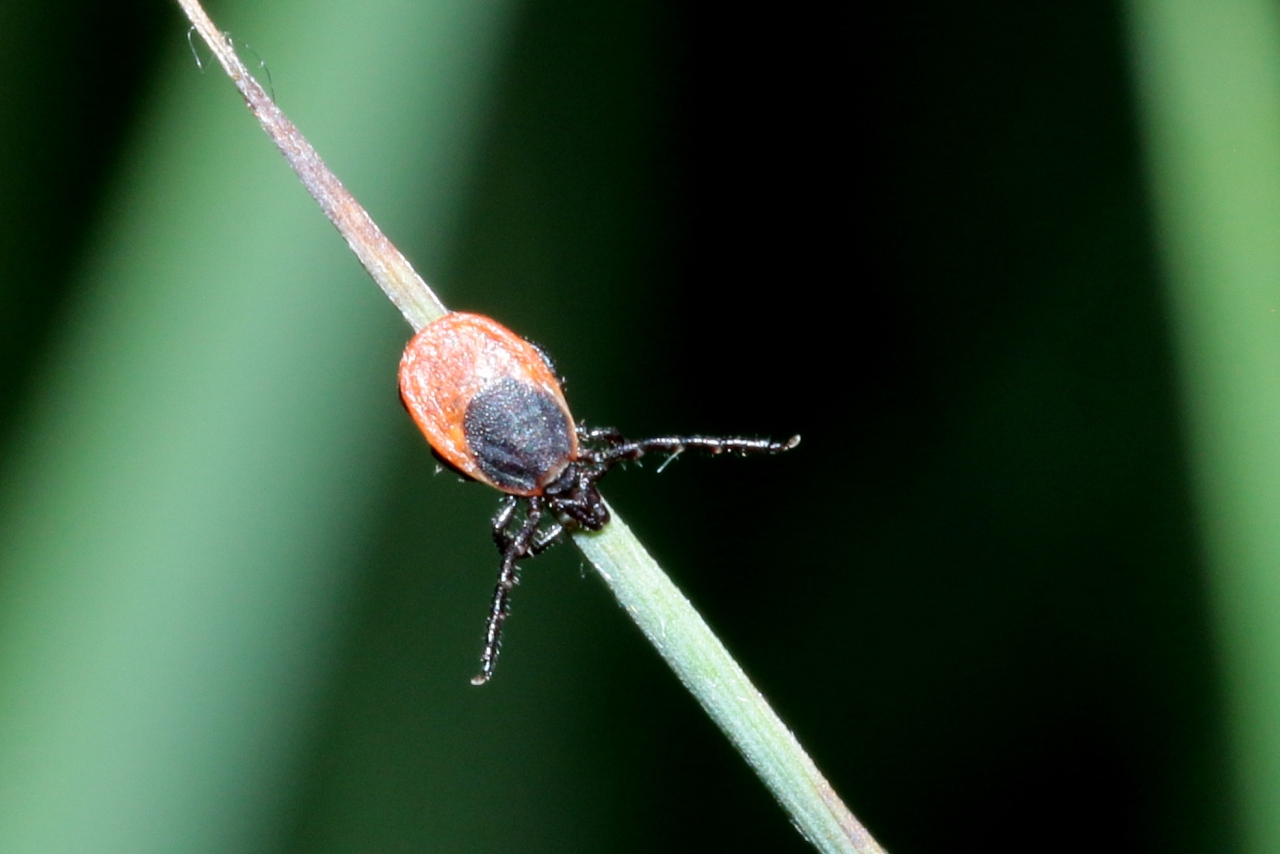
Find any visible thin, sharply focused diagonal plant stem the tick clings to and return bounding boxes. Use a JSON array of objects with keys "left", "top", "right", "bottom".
[{"left": 178, "top": 0, "right": 883, "bottom": 854}]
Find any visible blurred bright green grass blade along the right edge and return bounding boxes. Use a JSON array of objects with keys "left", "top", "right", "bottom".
[{"left": 1129, "top": 0, "right": 1280, "bottom": 854}]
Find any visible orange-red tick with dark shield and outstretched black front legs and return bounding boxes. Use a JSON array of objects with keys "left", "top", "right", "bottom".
[{"left": 399, "top": 311, "right": 800, "bottom": 685}]
